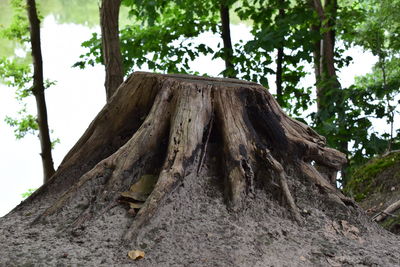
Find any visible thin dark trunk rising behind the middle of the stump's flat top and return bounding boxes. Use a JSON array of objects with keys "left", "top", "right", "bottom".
[{"left": 220, "top": 1, "right": 236, "bottom": 78}]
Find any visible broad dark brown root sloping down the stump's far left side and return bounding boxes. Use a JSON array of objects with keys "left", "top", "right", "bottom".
[{"left": 29, "top": 74, "right": 161, "bottom": 205}]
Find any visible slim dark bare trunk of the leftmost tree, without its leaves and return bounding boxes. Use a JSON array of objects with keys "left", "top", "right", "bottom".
[{"left": 27, "top": 0, "right": 55, "bottom": 183}]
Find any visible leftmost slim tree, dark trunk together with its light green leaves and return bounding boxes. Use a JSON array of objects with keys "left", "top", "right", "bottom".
[{"left": 0, "top": 0, "right": 58, "bottom": 182}]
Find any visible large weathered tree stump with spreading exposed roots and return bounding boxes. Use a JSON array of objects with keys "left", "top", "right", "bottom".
[{"left": 27, "top": 72, "right": 353, "bottom": 243}]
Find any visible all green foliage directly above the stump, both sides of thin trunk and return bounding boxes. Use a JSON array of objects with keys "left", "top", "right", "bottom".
[{"left": 74, "top": 0, "right": 319, "bottom": 116}]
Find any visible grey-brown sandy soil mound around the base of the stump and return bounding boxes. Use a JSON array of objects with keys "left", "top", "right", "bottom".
[{"left": 0, "top": 156, "right": 400, "bottom": 267}]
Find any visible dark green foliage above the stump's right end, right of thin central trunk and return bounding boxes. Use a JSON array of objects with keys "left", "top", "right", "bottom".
[{"left": 235, "top": 0, "right": 318, "bottom": 116}]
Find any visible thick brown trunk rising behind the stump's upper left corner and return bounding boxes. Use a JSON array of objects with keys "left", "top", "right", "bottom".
[{"left": 100, "top": 0, "right": 124, "bottom": 101}]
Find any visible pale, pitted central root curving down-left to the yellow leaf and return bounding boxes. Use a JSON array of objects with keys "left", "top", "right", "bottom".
[{"left": 123, "top": 84, "right": 212, "bottom": 242}]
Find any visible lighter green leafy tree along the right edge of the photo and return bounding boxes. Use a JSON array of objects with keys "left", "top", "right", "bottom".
[{"left": 346, "top": 0, "right": 400, "bottom": 154}]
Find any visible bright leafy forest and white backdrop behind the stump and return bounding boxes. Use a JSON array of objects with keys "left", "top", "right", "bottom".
[{"left": 0, "top": 0, "right": 400, "bottom": 216}]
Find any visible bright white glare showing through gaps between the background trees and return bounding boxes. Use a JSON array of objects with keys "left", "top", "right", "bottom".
[{"left": 0, "top": 16, "right": 382, "bottom": 216}]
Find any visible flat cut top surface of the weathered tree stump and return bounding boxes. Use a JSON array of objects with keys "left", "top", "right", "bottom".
[{"left": 132, "top": 71, "right": 263, "bottom": 87}]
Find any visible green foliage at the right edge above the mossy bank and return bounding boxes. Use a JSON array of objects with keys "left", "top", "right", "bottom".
[{"left": 312, "top": 0, "right": 400, "bottom": 188}]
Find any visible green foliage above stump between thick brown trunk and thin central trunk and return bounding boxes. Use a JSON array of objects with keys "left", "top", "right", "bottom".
[{"left": 74, "top": 1, "right": 217, "bottom": 73}]
